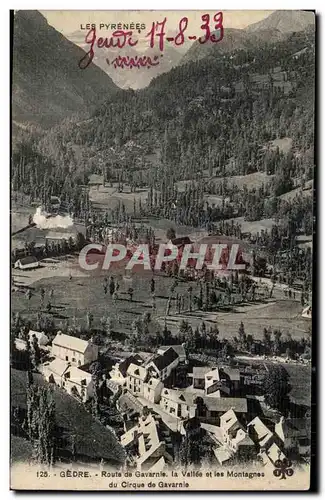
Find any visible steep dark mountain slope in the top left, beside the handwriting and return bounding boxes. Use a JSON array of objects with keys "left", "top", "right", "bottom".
[{"left": 12, "top": 10, "right": 118, "bottom": 128}]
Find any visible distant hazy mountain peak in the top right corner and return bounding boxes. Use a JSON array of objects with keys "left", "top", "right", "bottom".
[{"left": 245, "top": 10, "right": 315, "bottom": 33}]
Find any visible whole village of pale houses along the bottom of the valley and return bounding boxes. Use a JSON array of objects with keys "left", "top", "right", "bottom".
[{"left": 15, "top": 320, "right": 310, "bottom": 472}]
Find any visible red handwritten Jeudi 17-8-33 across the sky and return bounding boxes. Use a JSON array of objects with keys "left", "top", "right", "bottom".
[{"left": 79, "top": 12, "right": 224, "bottom": 69}]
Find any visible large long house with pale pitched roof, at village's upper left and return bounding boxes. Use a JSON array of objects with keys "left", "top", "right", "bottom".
[{"left": 52, "top": 332, "right": 98, "bottom": 366}]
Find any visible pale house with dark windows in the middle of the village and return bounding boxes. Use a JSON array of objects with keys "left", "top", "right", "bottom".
[{"left": 159, "top": 388, "right": 196, "bottom": 419}]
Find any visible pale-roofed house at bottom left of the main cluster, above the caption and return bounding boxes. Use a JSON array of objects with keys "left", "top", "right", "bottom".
[{"left": 120, "top": 413, "right": 174, "bottom": 471}]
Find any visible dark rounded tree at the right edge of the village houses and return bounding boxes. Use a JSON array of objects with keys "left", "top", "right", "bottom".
[{"left": 262, "top": 365, "right": 291, "bottom": 413}]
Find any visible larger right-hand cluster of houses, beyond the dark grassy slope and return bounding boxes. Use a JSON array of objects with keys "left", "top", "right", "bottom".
[{"left": 109, "top": 346, "right": 309, "bottom": 471}]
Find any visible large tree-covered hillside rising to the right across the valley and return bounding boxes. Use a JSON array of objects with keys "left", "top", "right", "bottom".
[{"left": 13, "top": 24, "right": 315, "bottom": 252}]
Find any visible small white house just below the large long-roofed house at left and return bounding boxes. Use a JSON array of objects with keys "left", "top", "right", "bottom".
[{"left": 62, "top": 365, "right": 94, "bottom": 402}]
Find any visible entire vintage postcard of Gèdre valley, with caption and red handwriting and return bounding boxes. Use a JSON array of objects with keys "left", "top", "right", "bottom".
[{"left": 10, "top": 10, "right": 317, "bottom": 493}]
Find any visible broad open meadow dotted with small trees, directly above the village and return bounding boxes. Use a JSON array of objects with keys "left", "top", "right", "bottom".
[{"left": 12, "top": 262, "right": 309, "bottom": 338}]
